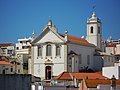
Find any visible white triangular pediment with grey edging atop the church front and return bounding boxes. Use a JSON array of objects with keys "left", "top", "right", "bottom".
[{"left": 32, "top": 27, "right": 66, "bottom": 44}]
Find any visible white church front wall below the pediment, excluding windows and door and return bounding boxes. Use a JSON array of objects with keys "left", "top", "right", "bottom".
[{"left": 34, "top": 44, "right": 64, "bottom": 77}]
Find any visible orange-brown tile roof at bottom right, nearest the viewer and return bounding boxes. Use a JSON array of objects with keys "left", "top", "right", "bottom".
[{"left": 85, "top": 79, "right": 120, "bottom": 88}]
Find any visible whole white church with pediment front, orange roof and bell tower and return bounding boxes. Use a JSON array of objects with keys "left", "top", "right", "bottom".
[{"left": 29, "top": 12, "right": 103, "bottom": 80}]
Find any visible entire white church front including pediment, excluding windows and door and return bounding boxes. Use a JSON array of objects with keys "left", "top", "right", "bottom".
[{"left": 33, "top": 30, "right": 67, "bottom": 79}]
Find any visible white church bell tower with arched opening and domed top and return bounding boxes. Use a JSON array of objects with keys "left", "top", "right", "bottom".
[{"left": 86, "top": 12, "right": 102, "bottom": 49}]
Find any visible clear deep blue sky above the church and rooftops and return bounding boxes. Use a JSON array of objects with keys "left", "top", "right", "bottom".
[{"left": 0, "top": 0, "right": 120, "bottom": 43}]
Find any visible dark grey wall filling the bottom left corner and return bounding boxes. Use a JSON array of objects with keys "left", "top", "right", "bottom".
[{"left": 0, "top": 74, "right": 32, "bottom": 90}]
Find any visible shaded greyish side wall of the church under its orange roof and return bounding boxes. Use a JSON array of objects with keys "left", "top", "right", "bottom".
[{"left": 68, "top": 44, "right": 95, "bottom": 69}]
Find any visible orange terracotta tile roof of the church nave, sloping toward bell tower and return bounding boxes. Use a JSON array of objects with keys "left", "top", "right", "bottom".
[{"left": 59, "top": 34, "right": 93, "bottom": 45}]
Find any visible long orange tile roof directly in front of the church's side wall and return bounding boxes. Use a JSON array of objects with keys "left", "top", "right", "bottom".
[{"left": 54, "top": 72, "right": 106, "bottom": 80}]
